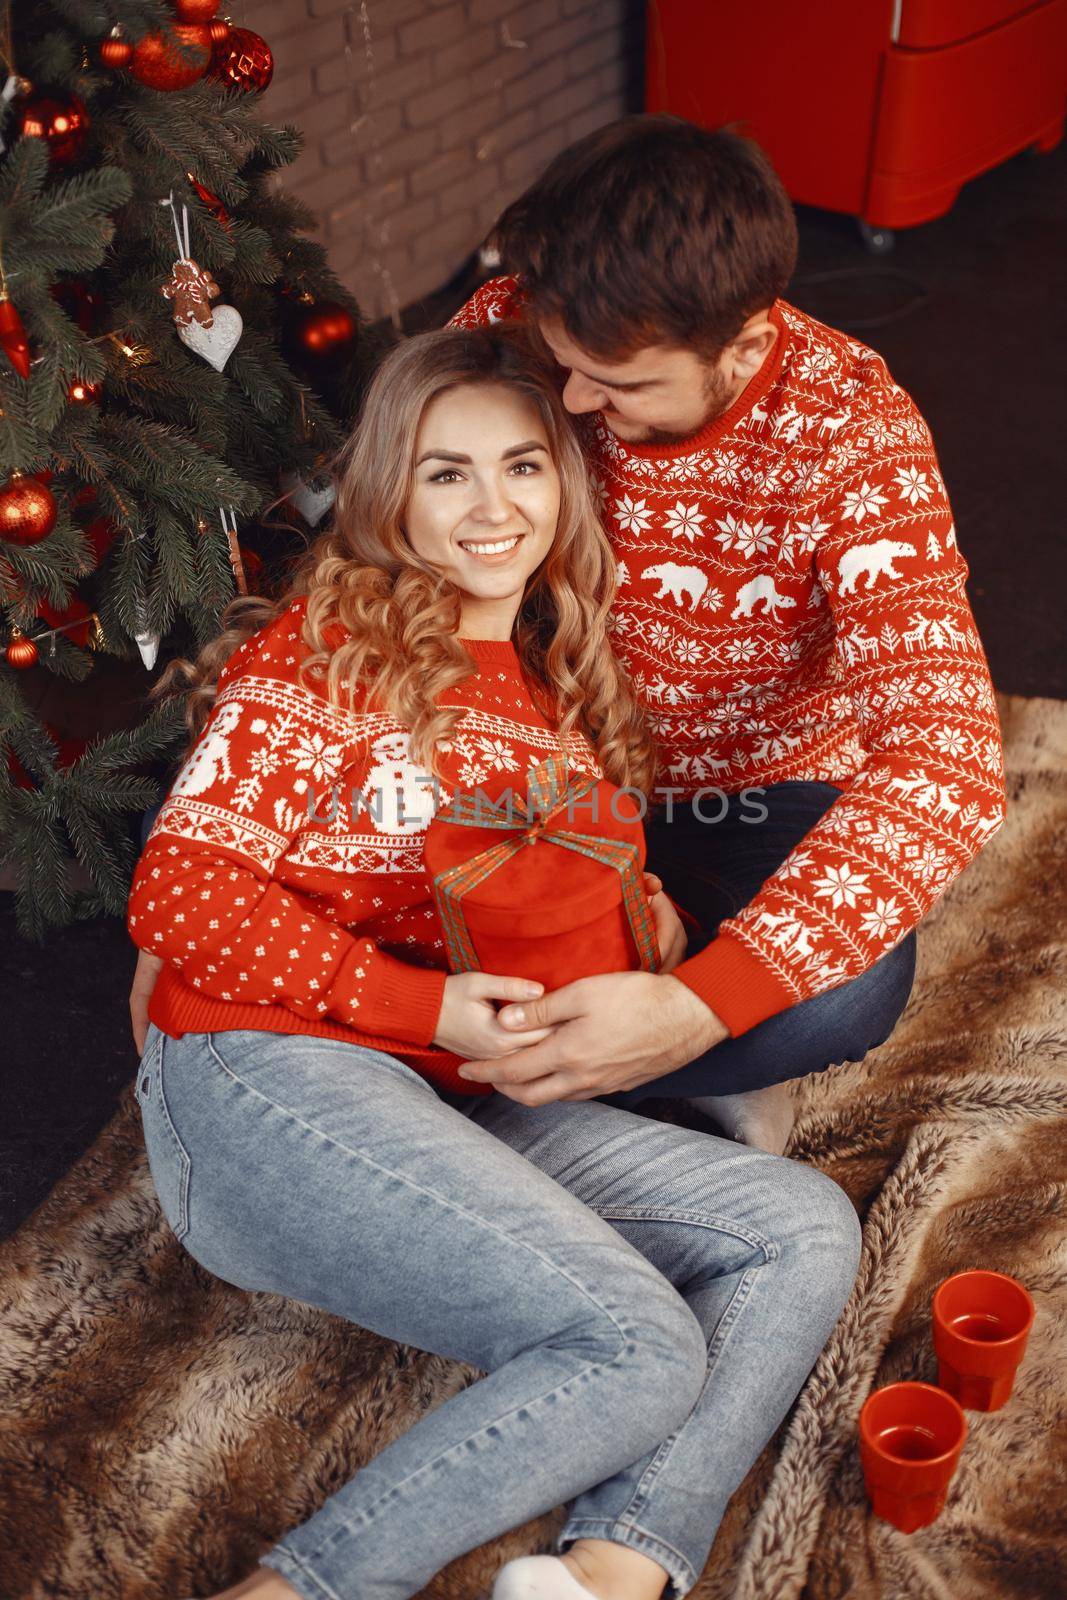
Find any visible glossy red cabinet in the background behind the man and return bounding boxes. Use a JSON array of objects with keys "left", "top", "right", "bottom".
[{"left": 646, "top": 0, "right": 1067, "bottom": 229}]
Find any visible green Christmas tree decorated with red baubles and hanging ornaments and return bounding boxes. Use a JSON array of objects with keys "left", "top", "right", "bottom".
[{"left": 0, "top": 0, "right": 370, "bottom": 938}]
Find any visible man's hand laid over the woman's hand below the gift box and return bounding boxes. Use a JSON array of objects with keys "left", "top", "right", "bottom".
[{"left": 461, "top": 973, "right": 728, "bottom": 1106}]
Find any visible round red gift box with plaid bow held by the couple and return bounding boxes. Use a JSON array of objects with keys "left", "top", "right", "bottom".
[{"left": 424, "top": 757, "right": 659, "bottom": 992}]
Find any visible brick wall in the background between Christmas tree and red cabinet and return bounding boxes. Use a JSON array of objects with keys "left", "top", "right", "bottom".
[{"left": 259, "top": 0, "right": 643, "bottom": 320}]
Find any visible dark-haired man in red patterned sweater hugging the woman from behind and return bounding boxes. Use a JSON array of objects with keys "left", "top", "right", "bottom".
[{"left": 444, "top": 115, "right": 1005, "bottom": 1149}]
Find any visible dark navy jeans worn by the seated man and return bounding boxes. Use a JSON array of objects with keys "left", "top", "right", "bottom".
[{"left": 605, "top": 784, "right": 915, "bottom": 1107}]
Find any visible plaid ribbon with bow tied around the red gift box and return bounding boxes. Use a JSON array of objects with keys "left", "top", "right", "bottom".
[{"left": 434, "top": 755, "right": 659, "bottom": 973}]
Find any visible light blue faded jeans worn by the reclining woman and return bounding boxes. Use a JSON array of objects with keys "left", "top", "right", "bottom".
[{"left": 136, "top": 1027, "right": 859, "bottom": 1600}]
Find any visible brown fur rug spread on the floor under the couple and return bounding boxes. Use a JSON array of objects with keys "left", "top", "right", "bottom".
[{"left": 0, "top": 701, "right": 1067, "bottom": 1600}]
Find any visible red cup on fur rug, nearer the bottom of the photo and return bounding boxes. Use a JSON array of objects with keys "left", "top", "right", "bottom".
[{"left": 859, "top": 1384, "right": 966, "bottom": 1533}]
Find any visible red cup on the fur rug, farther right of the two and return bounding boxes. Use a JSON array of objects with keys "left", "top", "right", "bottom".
[{"left": 934, "top": 1272, "right": 1033, "bottom": 1411}]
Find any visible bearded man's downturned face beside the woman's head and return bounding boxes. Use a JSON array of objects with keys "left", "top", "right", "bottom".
[{"left": 537, "top": 317, "right": 734, "bottom": 445}]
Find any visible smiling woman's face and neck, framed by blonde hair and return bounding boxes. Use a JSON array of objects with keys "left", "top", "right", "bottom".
[{"left": 402, "top": 384, "right": 560, "bottom": 638}]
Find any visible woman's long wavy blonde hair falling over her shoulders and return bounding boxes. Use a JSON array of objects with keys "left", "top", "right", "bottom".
[{"left": 152, "top": 325, "right": 654, "bottom": 794}]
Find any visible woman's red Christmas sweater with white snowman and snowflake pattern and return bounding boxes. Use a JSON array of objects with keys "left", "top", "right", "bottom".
[{"left": 126, "top": 600, "right": 603, "bottom": 1094}]
